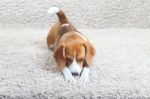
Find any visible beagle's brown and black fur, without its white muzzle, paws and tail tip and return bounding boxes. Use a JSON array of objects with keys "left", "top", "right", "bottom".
[{"left": 47, "top": 10, "right": 96, "bottom": 70}]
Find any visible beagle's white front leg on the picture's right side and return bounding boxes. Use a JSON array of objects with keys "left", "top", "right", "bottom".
[{"left": 80, "top": 67, "right": 89, "bottom": 83}]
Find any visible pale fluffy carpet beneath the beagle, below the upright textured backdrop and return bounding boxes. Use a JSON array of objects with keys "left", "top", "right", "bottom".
[{"left": 0, "top": 28, "right": 150, "bottom": 99}]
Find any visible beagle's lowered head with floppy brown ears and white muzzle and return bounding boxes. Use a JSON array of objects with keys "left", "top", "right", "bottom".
[{"left": 54, "top": 42, "right": 95, "bottom": 75}]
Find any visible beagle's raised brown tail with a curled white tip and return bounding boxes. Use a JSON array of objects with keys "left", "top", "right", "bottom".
[{"left": 48, "top": 7, "right": 69, "bottom": 24}]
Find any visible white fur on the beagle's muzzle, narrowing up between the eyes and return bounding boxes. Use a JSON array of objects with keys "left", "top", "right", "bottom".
[{"left": 69, "top": 58, "right": 82, "bottom": 74}]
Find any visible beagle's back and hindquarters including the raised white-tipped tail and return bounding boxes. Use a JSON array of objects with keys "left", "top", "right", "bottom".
[{"left": 47, "top": 7, "right": 78, "bottom": 50}]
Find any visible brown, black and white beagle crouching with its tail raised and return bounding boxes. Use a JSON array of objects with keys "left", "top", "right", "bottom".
[{"left": 47, "top": 7, "right": 96, "bottom": 83}]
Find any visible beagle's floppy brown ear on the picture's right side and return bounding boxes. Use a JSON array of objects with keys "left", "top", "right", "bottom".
[{"left": 83, "top": 42, "right": 96, "bottom": 66}]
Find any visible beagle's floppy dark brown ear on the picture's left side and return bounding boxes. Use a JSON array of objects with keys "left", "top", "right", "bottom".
[{"left": 54, "top": 44, "right": 66, "bottom": 70}]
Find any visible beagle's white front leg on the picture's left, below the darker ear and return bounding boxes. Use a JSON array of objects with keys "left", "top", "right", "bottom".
[{"left": 63, "top": 67, "right": 76, "bottom": 83}]
